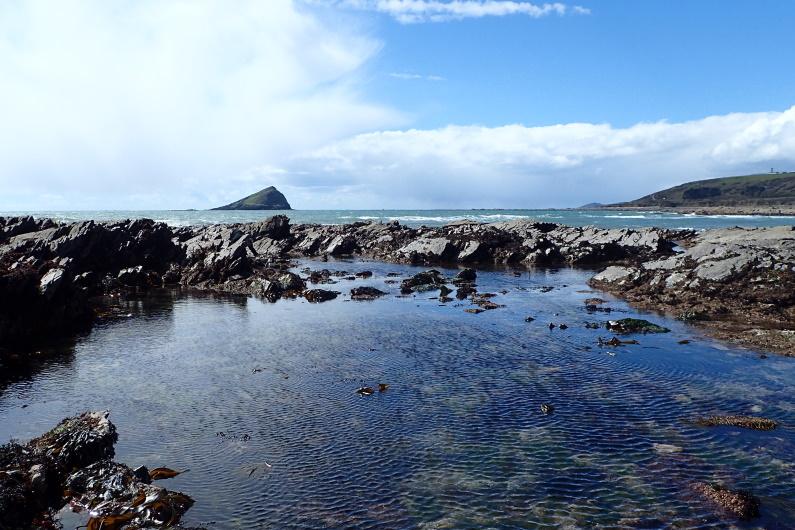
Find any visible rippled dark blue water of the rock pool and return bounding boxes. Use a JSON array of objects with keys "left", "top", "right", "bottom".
[{"left": 0, "top": 262, "right": 795, "bottom": 529}]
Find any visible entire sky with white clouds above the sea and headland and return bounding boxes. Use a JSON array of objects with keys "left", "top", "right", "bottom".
[{"left": 0, "top": 0, "right": 795, "bottom": 211}]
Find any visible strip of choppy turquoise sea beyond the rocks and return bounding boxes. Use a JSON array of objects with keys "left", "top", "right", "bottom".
[{"left": 0, "top": 209, "right": 795, "bottom": 229}]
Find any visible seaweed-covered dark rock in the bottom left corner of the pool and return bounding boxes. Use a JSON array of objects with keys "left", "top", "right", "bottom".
[{"left": 0, "top": 412, "right": 193, "bottom": 530}]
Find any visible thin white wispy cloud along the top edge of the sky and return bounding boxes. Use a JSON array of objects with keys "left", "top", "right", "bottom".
[{"left": 337, "top": 0, "right": 591, "bottom": 24}]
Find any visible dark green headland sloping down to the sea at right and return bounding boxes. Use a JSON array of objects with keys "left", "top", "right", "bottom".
[{"left": 611, "top": 172, "right": 795, "bottom": 208}]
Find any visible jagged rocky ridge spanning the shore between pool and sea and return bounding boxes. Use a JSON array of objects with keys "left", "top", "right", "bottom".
[{"left": 0, "top": 216, "right": 795, "bottom": 356}]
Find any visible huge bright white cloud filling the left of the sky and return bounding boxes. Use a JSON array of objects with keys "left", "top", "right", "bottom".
[{"left": 0, "top": 0, "right": 404, "bottom": 210}]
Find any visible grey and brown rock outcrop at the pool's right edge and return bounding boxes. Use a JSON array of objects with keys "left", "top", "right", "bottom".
[{"left": 591, "top": 226, "right": 795, "bottom": 355}]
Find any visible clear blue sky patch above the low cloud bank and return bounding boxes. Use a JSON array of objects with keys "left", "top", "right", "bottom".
[{"left": 370, "top": 0, "right": 795, "bottom": 128}]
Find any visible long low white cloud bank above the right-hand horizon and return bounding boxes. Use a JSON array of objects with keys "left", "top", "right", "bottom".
[{"left": 274, "top": 107, "right": 795, "bottom": 208}]
